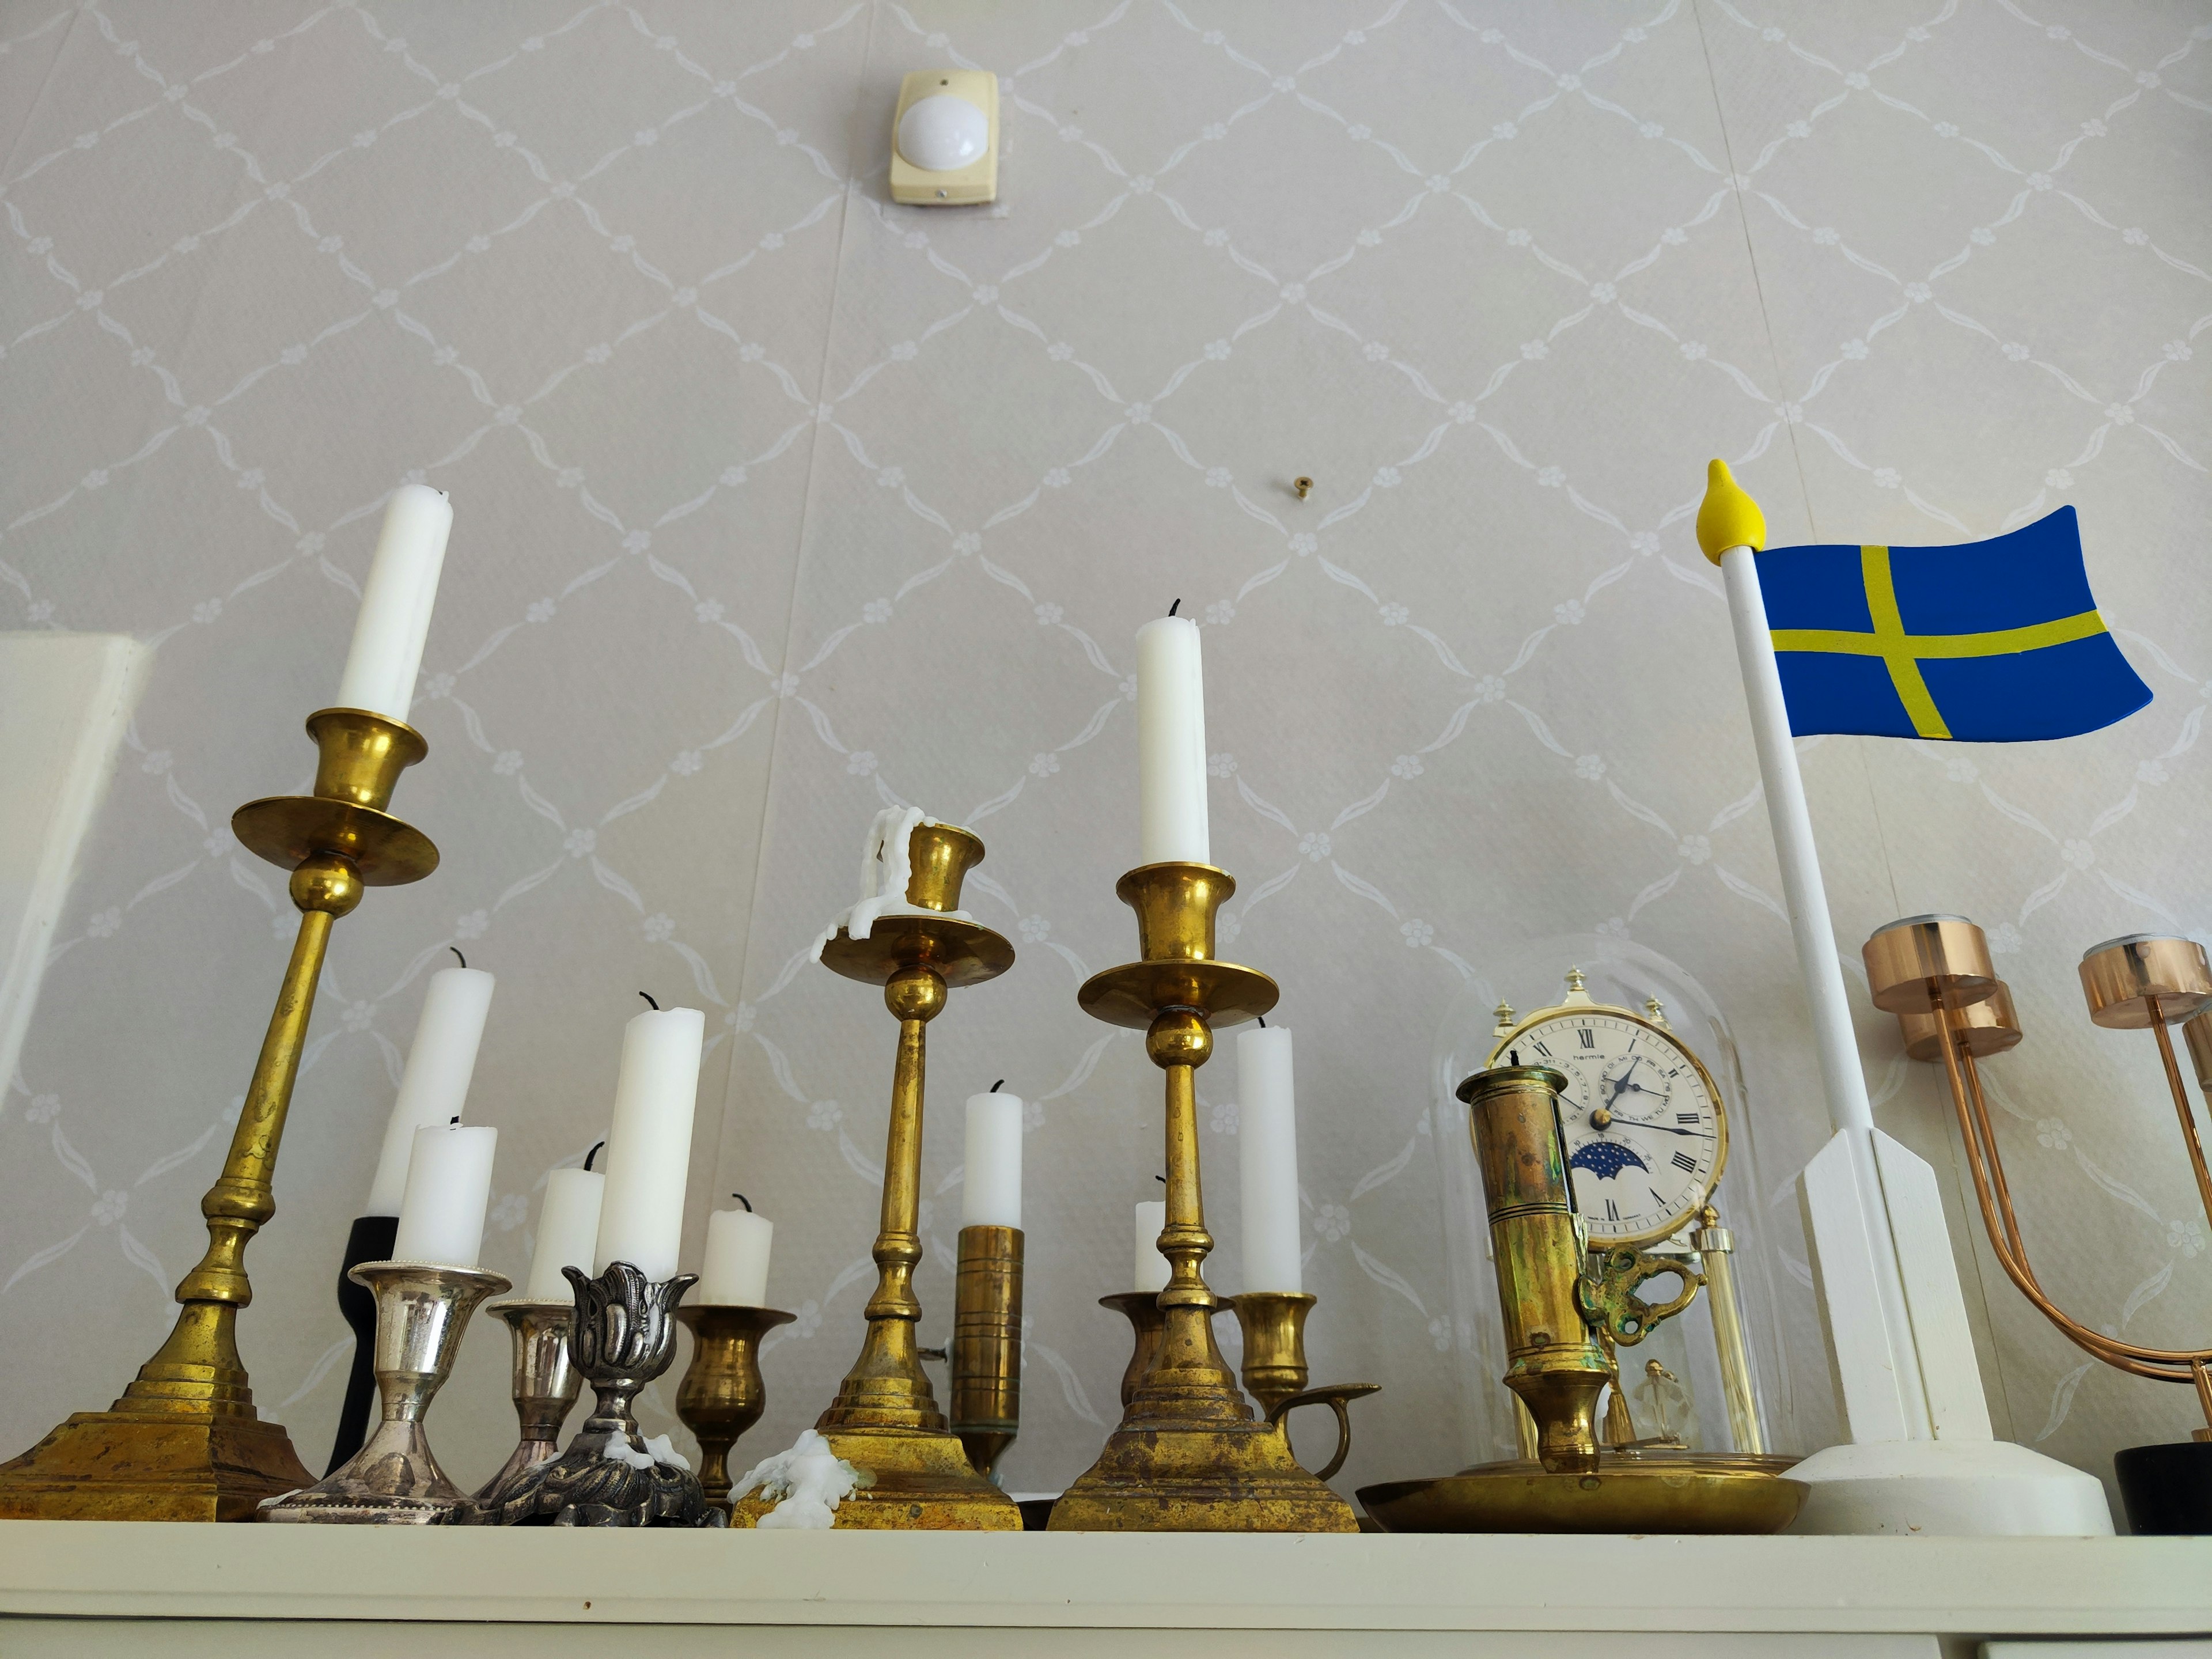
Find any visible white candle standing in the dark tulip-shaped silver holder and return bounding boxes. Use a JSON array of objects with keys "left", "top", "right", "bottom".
[{"left": 590, "top": 1009, "right": 706, "bottom": 1279}]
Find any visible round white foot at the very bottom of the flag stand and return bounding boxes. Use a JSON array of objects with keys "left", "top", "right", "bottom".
[{"left": 1787, "top": 1440, "right": 2112, "bottom": 1537}]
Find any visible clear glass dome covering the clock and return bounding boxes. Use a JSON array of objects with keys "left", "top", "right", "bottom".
[{"left": 1431, "top": 933, "right": 1809, "bottom": 1464}]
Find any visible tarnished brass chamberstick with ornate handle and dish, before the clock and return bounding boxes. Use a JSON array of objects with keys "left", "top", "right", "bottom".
[{"left": 1361, "top": 1055, "right": 1809, "bottom": 1533}]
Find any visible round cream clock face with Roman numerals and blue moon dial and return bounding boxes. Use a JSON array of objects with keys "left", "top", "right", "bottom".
[{"left": 1511, "top": 1009, "right": 1728, "bottom": 1245}]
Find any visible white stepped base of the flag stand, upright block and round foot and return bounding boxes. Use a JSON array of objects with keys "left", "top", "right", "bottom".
[{"left": 1790, "top": 1128, "right": 2112, "bottom": 1537}]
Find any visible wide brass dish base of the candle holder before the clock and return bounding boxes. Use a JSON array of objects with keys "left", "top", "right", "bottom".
[{"left": 1358, "top": 1449, "right": 1812, "bottom": 1533}]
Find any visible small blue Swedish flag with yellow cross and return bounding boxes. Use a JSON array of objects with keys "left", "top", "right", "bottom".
[{"left": 1759, "top": 506, "right": 2150, "bottom": 743}]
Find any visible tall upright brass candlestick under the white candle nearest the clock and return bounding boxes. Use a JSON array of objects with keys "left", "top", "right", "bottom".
[{"left": 1051, "top": 863, "right": 1358, "bottom": 1533}]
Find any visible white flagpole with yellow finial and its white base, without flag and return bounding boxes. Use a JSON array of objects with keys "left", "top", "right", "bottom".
[{"left": 1696, "top": 460, "right": 2112, "bottom": 1533}]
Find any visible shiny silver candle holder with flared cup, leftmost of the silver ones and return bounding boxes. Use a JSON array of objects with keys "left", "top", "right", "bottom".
[{"left": 256, "top": 1261, "right": 513, "bottom": 1527}]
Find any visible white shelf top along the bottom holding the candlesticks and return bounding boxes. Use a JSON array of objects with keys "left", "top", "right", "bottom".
[{"left": 0, "top": 1522, "right": 2212, "bottom": 1659}]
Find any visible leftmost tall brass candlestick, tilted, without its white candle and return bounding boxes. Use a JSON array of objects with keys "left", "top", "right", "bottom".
[{"left": 0, "top": 708, "right": 438, "bottom": 1520}]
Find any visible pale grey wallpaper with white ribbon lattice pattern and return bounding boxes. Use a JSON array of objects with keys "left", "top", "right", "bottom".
[{"left": 0, "top": 0, "right": 2212, "bottom": 1521}]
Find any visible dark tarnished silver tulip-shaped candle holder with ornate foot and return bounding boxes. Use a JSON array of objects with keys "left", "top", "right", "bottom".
[{"left": 456, "top": 1261, "right": 728, "bottom": 1527}]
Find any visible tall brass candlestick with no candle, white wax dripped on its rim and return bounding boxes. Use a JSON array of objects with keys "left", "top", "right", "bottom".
[{"left": 730, "top": 823, "right": 1022, "bottom": 1533}]
